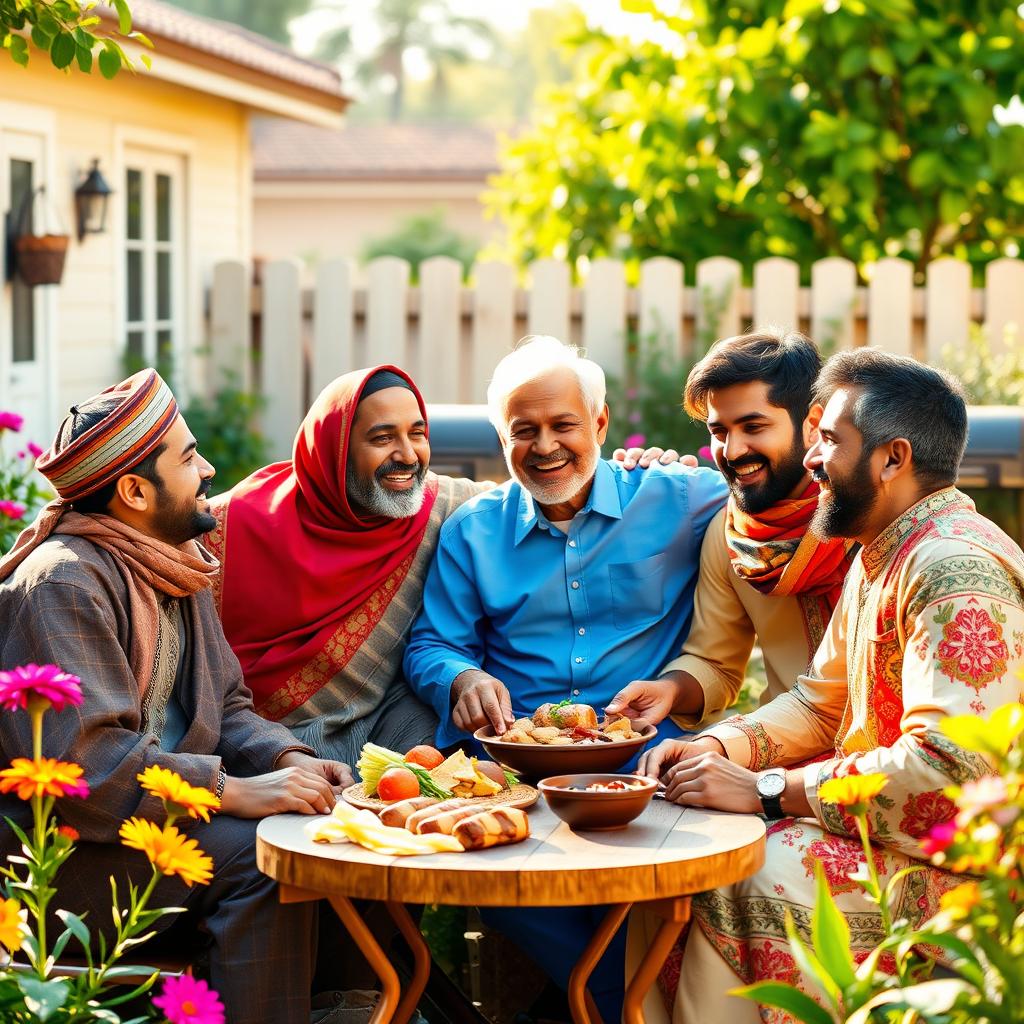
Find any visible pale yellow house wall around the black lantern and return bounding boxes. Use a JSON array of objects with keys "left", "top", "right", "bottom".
[{"left": 0, "top": 53, "right": 252, "bottom": 423}]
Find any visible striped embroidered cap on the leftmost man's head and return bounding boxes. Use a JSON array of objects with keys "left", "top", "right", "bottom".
[{"left": 36, "top": 370, "right": 178, "bottom": 502}]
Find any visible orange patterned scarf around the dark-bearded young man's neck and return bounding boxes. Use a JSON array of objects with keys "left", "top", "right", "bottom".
[{"left": 725, "top": 480, "right": 857, "bottom": 613}]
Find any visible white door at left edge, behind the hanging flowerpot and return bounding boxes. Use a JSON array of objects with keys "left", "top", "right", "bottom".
[{"left": 0, "top": 129, "right": 52, "bottom": 447}]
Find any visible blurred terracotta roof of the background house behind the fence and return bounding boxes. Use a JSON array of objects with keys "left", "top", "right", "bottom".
[{"left": 252, "top": 118, "right": 498, "bottom": 181}]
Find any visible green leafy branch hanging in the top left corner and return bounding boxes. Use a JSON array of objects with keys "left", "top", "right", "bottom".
[{"left": 0, "top": 0, "right": 153, "bottom": 78}]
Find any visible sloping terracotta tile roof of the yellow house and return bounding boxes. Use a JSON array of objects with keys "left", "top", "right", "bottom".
[{"left": 111, "top": 0, "right": 344, "bottom": 97}]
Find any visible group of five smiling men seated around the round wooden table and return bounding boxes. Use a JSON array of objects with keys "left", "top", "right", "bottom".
[{"left": 0, "top": 331, "right": 1024, "bottom": 1024}]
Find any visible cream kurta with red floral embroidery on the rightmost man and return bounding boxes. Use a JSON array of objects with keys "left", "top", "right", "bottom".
[{"left": 663, "top": 487, "right": 1024, "bottom": 1024}]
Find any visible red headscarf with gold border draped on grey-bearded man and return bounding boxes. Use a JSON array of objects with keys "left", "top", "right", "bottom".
[{"left": 211, "top": 366, "right": 437, "bottom": 719}]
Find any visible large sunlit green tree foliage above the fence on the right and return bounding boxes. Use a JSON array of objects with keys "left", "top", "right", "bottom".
[{"left": 492, "top": 0, "right": 1024, "bottom": 280}]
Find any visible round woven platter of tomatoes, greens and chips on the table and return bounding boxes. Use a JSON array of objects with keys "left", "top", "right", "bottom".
[{"left": 341, "top": 743, "right": 539, "bottom": 811}]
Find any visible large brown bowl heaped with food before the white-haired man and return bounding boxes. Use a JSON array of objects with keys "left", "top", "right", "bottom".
[{"left": 473, "top": 700, "right": 657, "bottom": 779}]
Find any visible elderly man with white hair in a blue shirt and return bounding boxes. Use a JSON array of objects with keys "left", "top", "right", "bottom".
[{"left": 403, "top": 337, "right": 727, "bottom": 1020}]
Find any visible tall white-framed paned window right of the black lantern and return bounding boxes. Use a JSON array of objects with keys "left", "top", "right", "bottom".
[{"left": 119, "top": 147, "right": 185, "bottom": 389}]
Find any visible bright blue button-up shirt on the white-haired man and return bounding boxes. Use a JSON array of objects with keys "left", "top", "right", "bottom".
[{"left": 403, "top": 460, "right": 726, "bottom": 745}]
